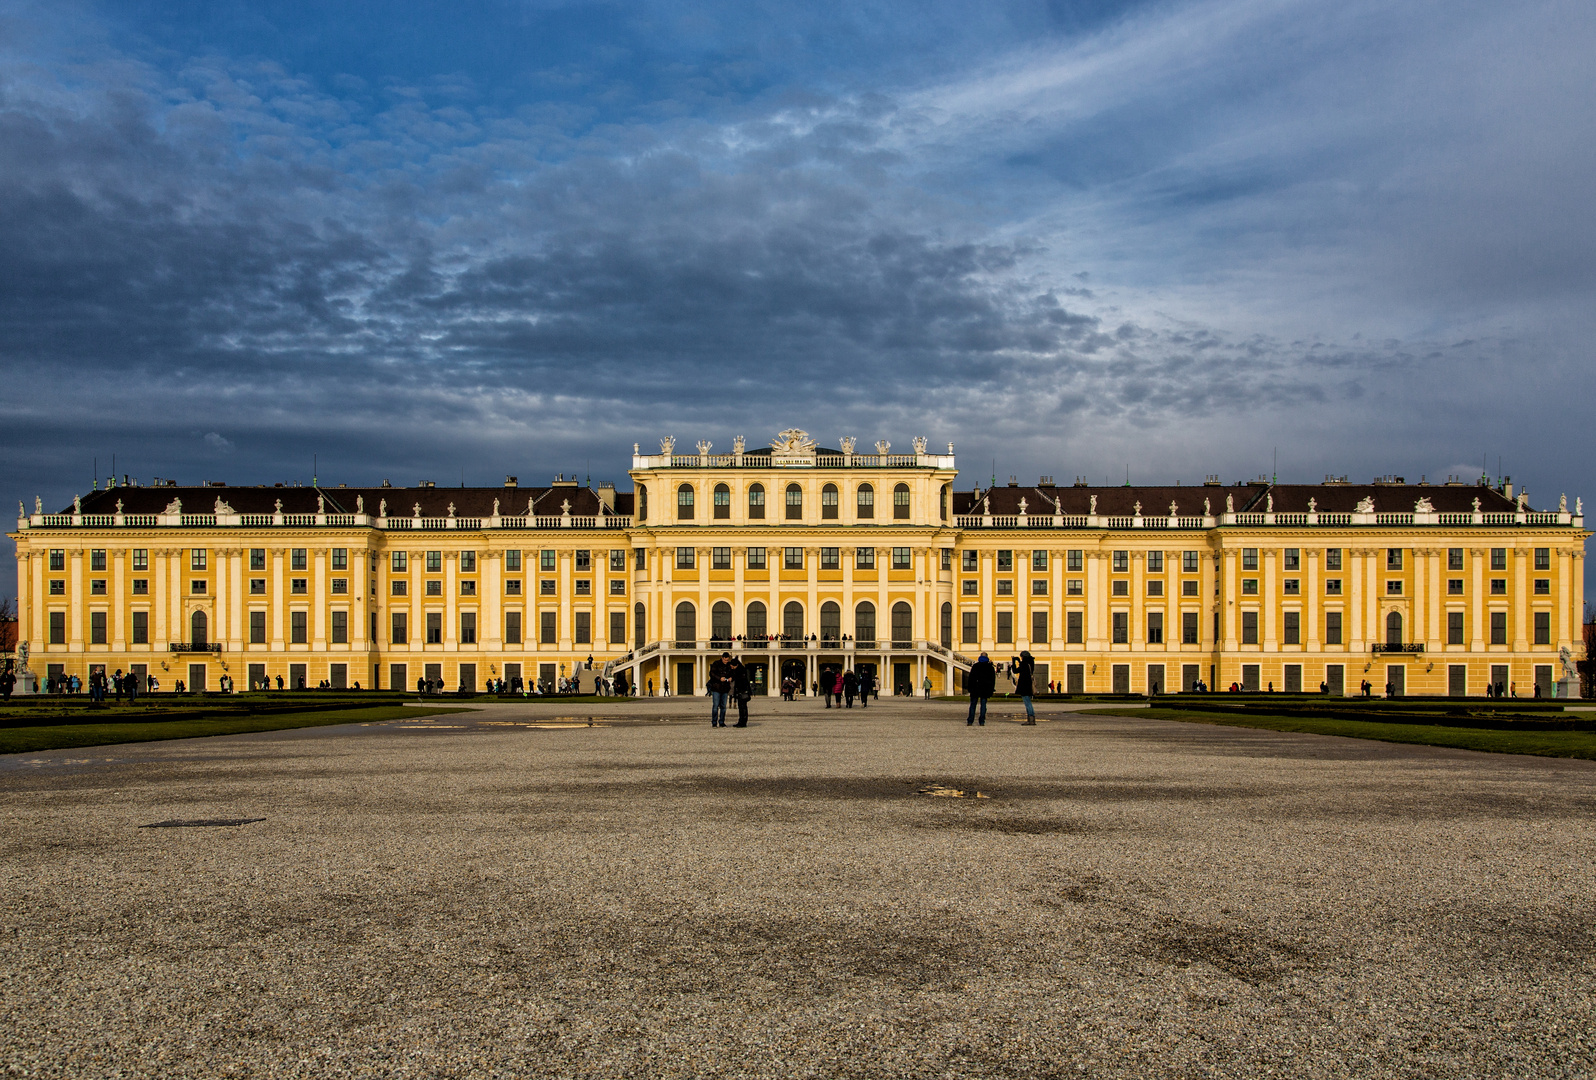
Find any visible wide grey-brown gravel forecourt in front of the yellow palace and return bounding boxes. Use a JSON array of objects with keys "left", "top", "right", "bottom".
[{"left": 0, "top": 700, "right": 1596, "bottom": 1077}]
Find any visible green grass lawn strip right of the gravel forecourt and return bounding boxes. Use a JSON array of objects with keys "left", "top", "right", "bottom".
[{"left": 1077, "top": 708, "right": 1596, "bottom": 759}]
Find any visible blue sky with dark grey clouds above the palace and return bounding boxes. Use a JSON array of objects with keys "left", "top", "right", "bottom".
[{"left": 0, "top": 0, "right": 1596, "bottom": 592}]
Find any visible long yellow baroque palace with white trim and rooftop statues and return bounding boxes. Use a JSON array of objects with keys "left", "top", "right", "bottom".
[{"left": 13, "top": 431, "right": 1588, "bottom": 696}]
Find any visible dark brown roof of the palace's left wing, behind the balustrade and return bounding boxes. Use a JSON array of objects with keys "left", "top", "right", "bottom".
[{"left": 70, "top": 485, "right": 632, "bottom": 517}]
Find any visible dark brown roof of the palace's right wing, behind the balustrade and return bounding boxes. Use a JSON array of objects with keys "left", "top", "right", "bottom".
[{"left": 953, "top": 483, "right": 1513, "bottom": 517}]
